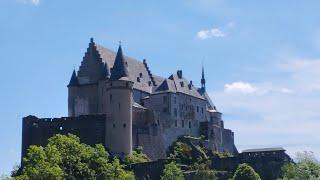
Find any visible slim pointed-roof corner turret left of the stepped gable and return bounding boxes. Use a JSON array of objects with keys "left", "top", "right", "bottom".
[{"left": 68, "top": 70, "right": 79, "bottom": 117}]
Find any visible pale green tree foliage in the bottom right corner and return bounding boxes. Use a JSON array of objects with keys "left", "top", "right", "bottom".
[{"left": 282, "top": 152, "right": 320, "bottom": 180}]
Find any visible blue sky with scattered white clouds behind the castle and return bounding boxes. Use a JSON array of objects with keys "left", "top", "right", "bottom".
[{"left": 0, "top": 0, "right": 320, "bottom": 174}]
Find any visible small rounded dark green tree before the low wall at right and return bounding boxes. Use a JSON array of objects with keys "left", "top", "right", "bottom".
[{"left": 233, "top": 163, "right": 261, "bottom": 180}]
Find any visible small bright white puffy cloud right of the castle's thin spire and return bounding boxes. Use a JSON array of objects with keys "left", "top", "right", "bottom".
[{"left": 224, "top": 81, "right": 257, "bottom": 94}]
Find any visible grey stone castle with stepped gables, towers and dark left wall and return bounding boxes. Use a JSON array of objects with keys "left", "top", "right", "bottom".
[{"left": 22, "top": 38, "right": 237, "bottom": 160}]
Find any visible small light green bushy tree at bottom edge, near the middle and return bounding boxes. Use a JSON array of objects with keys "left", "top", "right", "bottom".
[{"left": 161, "top": 162, "right": 184, "bottom": 180}]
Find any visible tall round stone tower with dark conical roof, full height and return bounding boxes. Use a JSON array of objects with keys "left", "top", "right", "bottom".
[{"left": 106, "top": 45, "right": 133, "bottom": 156}]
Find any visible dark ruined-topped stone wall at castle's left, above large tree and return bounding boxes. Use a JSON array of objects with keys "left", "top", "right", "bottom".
[{"left": 21, "top": 114, "right": 106, "bottom": 159}]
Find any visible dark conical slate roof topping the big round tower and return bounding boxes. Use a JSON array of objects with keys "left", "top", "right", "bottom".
[{"left": 110, "top": 44, "right": 129, "bottom": 80}]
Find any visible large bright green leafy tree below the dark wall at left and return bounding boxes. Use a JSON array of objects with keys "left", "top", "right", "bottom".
[{"left": 15, "top": 134, "right": 134, "bottom": 180}]
